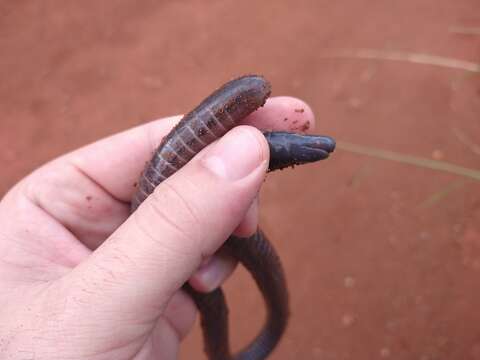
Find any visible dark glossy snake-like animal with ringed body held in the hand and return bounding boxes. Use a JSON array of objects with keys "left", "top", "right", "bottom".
[{"left": 131, "top": 75, "right": 335, "bottom": 360}]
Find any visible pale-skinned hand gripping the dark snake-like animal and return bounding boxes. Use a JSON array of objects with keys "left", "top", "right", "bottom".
[{"left": 0, "top": 97, "right": 314, "bottom": 360}]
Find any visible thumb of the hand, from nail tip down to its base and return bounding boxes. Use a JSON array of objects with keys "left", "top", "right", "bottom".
[{"left": 62, "top": 126, "right": 269, "bottom": 327}]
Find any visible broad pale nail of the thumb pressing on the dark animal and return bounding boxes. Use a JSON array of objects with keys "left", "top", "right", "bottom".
[{"left": 202, "top": 126, "right": 266, "bottom": 180}]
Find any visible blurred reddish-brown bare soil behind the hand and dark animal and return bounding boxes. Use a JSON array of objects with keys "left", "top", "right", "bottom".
[{"left": 0, "top": 0, "right": 480, "bottom": 360}]
